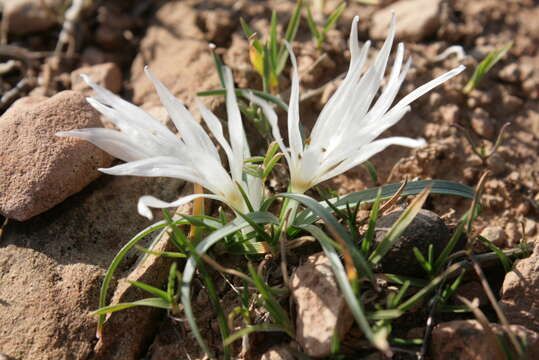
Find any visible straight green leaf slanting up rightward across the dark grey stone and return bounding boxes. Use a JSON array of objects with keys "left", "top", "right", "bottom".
[{"left": 369, "top": 187, "right": 430, "bottom": 264}]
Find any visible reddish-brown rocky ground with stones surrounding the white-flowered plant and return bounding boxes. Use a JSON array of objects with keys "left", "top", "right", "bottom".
[{"left": 0, "top": 0, "right": 539, "bottom": 360}]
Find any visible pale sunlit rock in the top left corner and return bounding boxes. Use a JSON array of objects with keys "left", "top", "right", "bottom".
[{"left": 0, "top": 0, "right": 63, "bottom": 35}]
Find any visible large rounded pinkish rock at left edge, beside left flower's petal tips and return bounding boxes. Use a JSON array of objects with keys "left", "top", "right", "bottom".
[{"left": 0, "top": 91, "right": 112, "bottom": 221}]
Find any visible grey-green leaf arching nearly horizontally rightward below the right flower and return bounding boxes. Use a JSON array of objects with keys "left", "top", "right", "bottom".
[{"left": 294, "top": 180, "right": 474, "bottom": 225}]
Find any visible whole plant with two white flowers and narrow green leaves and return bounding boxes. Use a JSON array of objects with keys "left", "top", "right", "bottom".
[{"left": 58, "top": 13, "right": 480, "bottom": 359}]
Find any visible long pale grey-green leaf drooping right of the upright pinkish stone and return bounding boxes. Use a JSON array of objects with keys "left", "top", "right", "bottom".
[{"left": 302, "top": 225, "right": 389, "bottom": 352}]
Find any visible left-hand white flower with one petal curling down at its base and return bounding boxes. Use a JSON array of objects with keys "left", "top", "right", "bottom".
[{"left": 57, "top": 68, "right": 263, "bottom": 219}]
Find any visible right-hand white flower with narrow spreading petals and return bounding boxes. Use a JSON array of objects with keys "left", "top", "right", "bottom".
[{"left": 251, "top": 17, "right": 464, "bottom": 193}]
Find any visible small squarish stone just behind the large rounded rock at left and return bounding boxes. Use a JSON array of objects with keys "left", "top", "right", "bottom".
[{"left": 71, "top": 62, "right": 122, "bottom": 95}]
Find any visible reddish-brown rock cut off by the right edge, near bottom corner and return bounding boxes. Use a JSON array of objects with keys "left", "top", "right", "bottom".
[{"left": 500, "top": 248, "right": 539, "bottom": 332}]
